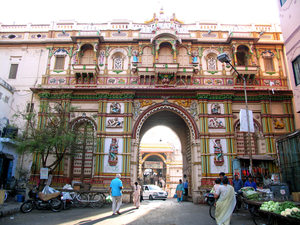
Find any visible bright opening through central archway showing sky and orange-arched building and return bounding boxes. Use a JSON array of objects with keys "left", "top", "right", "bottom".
[{"left": 140, "top": 126, "right": 185, "bottom": 196}]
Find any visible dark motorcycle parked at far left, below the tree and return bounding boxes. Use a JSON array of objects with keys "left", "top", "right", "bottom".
[{"left": 20, "top": 189, "right": 63, "bottom": 213}]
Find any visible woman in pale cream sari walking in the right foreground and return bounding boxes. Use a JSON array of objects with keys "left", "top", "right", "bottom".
[{"left": 214, "top": 177, "right": 236, "bottom": 225}]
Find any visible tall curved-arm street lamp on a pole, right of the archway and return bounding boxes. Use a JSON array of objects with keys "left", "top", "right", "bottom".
[{"left": 217, "top": 53, "right": 252, "bottom": 175}]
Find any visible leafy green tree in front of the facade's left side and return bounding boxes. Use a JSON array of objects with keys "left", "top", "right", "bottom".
[{"left": 14, "top": 102, "right": 91, "bottom": 174}]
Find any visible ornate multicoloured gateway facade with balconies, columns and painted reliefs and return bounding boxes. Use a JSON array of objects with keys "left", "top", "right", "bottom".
[{"left": 0, "top": 10, "right": 294, "bottom": 201}]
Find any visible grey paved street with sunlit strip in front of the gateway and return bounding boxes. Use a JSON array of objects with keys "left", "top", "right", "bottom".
[{"left": 0, "top": 199, "right": 268, "bottom": 225}]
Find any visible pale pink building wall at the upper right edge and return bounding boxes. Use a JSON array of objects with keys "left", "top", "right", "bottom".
[{"left": 277, "top": 0, "right": 300, "bottom": 129}]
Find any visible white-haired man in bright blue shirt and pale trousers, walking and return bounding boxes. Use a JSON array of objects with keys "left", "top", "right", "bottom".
[{"left": 108, "top": 174, "right": 123, "bottom": 215}]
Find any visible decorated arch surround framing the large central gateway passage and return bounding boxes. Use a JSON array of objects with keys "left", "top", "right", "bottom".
[{"left": 132, "top": 103, "right": 202, "bottom": 201}]
